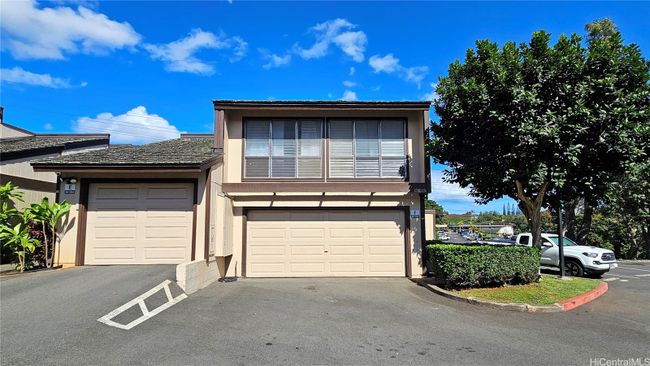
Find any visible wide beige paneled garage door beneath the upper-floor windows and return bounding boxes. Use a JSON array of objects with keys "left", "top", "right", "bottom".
[{"left": 246, "top": 209, "right": 405, "bottom": 277}]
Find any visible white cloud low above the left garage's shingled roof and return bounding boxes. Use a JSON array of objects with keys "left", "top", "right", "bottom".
[{"left": 72, "top": 106, "right": 180, "bottom": 144}]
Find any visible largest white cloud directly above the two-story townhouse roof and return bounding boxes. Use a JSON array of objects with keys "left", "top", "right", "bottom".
[{"left": 294, "top": 18, "right": 368, "bottom": 62}]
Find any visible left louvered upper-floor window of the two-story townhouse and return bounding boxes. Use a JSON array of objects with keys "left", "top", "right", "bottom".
[{"left": 244, "top": 119, "right": 323, "bottom": 178}]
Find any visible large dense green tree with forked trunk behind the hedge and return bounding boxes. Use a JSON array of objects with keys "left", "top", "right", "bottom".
[{"left": 427, "top": 20, "right": 650, "bottom": 249}]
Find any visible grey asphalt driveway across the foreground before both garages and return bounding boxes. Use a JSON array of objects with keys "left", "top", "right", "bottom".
[{"left": 0, "top": 266, "right": 650, "bottom": 365}]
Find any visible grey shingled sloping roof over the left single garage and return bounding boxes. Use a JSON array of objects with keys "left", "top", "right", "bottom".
[{"left": 32, "top": 135, "right": 223, "bottom": 169}]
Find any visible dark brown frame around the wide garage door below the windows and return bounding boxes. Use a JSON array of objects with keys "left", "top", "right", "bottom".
[{"left": 241, "top": 206, "right": 411, "bottom": 277}]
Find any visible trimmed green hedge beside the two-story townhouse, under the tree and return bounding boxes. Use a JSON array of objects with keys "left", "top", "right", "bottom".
[{"left": 427, "top": 244, "right": 540, "bottom": 288}]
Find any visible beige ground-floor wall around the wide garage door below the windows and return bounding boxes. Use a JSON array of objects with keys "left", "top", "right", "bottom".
[{"left": 220, "top": 193, "right": 424, "bottom": 278}]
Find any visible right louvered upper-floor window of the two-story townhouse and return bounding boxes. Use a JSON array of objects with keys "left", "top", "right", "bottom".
[{"left": 329, "top": 119, "right": 406, "bottom": 178}]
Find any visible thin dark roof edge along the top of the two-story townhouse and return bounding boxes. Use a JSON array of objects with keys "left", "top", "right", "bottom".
[{"left": 212, "top": 99, "right": 431, "bottom": 110}]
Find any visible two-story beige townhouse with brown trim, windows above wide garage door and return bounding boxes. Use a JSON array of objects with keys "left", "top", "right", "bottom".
[{"left": 214, "top": 100, "right": 429, "bottom": 277}]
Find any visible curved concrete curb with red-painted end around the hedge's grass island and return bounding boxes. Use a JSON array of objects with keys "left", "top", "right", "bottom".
[{"left": 416, "top": 279, "right": 608, "bottom": 313}]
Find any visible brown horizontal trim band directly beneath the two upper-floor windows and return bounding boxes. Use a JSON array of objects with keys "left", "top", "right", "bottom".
[{"left": 223, "top": 182, "right": 424, "bottom": 193}]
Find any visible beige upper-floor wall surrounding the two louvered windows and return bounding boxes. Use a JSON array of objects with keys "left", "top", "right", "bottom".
[{"left": 224, "top": 110, "right": 428, "bottom": 183}]
